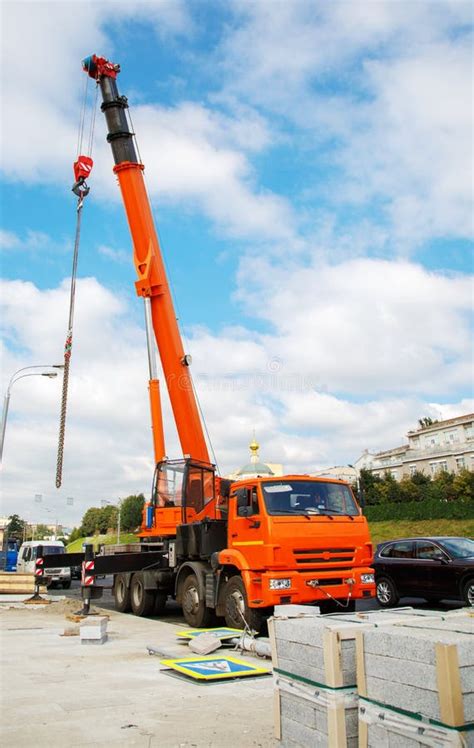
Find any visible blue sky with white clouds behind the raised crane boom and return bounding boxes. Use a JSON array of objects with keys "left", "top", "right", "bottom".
[{"left": 0, "top": 0, "right": 473, "bottom": 524}]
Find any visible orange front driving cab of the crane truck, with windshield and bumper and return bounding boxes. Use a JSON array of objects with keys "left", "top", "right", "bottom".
[{"left": 219, "top": 475, "right": 375, "bottom": 609}]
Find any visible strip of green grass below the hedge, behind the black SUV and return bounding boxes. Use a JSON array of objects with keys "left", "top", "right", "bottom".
[{"left": 369, "top": 519, "right": 474, "bottom": 546}]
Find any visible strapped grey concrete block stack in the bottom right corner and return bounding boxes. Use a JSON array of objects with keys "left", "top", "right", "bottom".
[{"left": 356, "top": 613, "right": 474, "bottom": 748}]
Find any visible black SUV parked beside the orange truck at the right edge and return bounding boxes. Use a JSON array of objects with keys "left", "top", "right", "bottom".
[{"left": 373, "top": 537, "right": 474, "bottom": 608}]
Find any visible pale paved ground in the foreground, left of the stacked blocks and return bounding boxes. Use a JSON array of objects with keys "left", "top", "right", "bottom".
[{"left": 0, "top": 604, "right": 273, "bottom": 748}]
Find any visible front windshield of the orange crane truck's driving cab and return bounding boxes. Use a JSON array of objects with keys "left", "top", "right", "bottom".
[{"left": 262, "top": 480, "right": 359, "bottom": 517}]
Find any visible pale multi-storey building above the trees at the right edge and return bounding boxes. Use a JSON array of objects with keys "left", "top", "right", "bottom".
[{"left": 355, "top": 413, "right": 474, "bottom": 480}]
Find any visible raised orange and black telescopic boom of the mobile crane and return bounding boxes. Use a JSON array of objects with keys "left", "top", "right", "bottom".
[{"left": 83, "top": 55, "right": 209, "bottom": 463}]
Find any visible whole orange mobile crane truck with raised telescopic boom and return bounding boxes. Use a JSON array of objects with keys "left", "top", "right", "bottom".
[{"left": 48, "top": 55, "right": 375, "bottom": 631}]
